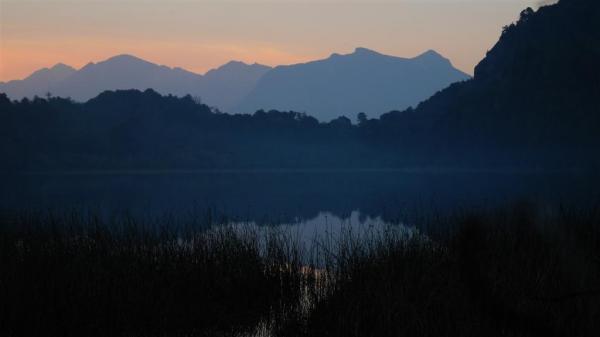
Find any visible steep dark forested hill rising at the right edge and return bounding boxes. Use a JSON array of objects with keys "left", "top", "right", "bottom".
[{"left": 372, "top": 0, "right": 600, "bottom": 165}]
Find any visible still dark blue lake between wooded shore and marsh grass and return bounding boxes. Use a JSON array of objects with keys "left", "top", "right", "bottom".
[{"left": 0, "top": 170, "right": 600, "bottom": 225}]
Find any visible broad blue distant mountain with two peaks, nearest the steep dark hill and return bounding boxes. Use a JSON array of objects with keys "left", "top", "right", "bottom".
[{"left": 235, "top": 48, "right": 469, "bottom": 121}]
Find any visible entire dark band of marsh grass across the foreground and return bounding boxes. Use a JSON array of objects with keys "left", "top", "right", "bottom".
[{"left": 0, "top": 205, "right": 600, "bottom": 336}]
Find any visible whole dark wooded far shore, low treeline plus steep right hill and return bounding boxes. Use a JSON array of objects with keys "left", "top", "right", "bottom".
[{"left": 0, "top": 0, "right": 600, "bottom": 169}]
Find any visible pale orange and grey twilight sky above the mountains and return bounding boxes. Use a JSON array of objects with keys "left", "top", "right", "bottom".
[{"left": 0, "top": 0, "right": 546, "bottom": 81}]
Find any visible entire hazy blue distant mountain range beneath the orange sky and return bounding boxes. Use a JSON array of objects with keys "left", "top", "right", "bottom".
[{"left": 0, "top": 48, "right": 469, "bottom": 121}]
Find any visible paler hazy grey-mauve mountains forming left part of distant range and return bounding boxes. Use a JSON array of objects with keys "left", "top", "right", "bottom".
[{"left": 0, "top": 55, "right": 270, "bottom": 110}]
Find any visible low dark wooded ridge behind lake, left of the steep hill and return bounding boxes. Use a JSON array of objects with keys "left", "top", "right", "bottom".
[{"left": 0, "top": 89, "right": 384, "bottom": 170}]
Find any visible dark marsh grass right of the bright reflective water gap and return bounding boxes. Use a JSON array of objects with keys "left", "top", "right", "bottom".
[{"left": 281, "top": 204, "right": 600, "bottom": 336}]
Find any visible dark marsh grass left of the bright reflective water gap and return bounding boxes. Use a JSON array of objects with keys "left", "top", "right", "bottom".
[{"left": 0, "top": 214, "right": 299, "bottom": 336}]
